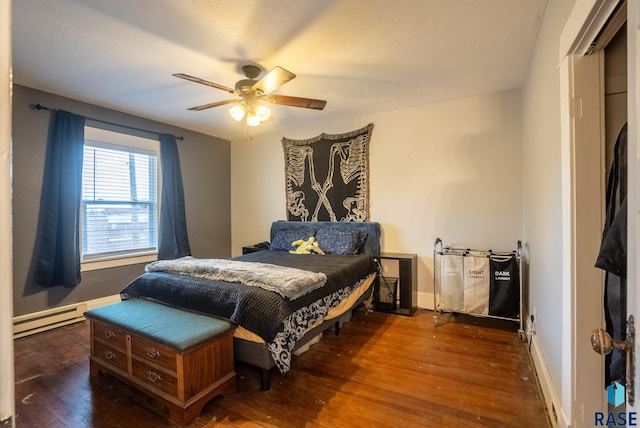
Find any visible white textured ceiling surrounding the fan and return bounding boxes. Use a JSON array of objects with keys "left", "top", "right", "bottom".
[{"left": 12, "top": 0, "right": 547, "bottom": 139}]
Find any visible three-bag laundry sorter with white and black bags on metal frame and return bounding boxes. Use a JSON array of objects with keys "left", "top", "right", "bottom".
[{"left": 433, "top": 238, "right": 525, "bottom": 340}]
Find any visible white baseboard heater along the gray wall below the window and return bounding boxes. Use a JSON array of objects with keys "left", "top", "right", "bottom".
[{"left": 13, "top": 303, "right": 87, "bottom": 339}]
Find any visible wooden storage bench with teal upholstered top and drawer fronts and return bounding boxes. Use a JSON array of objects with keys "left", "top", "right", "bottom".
[{"left": 85, "top": 299, "right": 235, "bottom": 424}]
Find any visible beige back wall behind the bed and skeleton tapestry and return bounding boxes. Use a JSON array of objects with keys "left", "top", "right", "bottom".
[{"left": 231, "top": 90, "right": 522, "bottom": 307}]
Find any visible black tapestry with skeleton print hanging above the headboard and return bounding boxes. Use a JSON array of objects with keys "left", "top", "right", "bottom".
[{"left": 282, "top": 123, "right": 373, "bottom": 222}]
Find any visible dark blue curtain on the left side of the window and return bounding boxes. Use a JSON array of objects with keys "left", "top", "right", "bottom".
[{"left": 35, "top": 110, "right": 85, "bottom": 287}]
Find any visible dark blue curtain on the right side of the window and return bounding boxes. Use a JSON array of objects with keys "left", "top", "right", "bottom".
[{"left": 158, "top": 134, "right": 191, "bottom": 259}]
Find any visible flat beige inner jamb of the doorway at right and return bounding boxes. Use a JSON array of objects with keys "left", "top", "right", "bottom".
[{"left": 562, "top": 50, "right": 607, "bottom": 426}]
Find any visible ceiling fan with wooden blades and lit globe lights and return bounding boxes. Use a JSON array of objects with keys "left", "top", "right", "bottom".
[{"left": 173, "top": 64, "right": 327, "bottom": 126}]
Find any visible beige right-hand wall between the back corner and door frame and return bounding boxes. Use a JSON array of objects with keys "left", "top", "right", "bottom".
[{"left": 522, "top": 1, "right": 575, "bottom": 422}]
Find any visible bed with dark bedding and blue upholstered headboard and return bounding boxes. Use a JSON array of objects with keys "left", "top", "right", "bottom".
[{"left": 120, "top": 221, "right": 380, "bottom": 391}]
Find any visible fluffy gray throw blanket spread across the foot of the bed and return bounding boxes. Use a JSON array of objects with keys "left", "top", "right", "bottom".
[{"left": 145, "top": 256, "right": 327, "bottom": 300}]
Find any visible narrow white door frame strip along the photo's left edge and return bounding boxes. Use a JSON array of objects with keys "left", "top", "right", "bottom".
[{"left": 0, "top": 0, "right": 15, "bottom": 426}]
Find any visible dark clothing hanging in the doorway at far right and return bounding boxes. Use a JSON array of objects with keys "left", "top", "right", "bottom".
[{"left": 595, "top": 123, "right": 627, "bottom": 385}]
